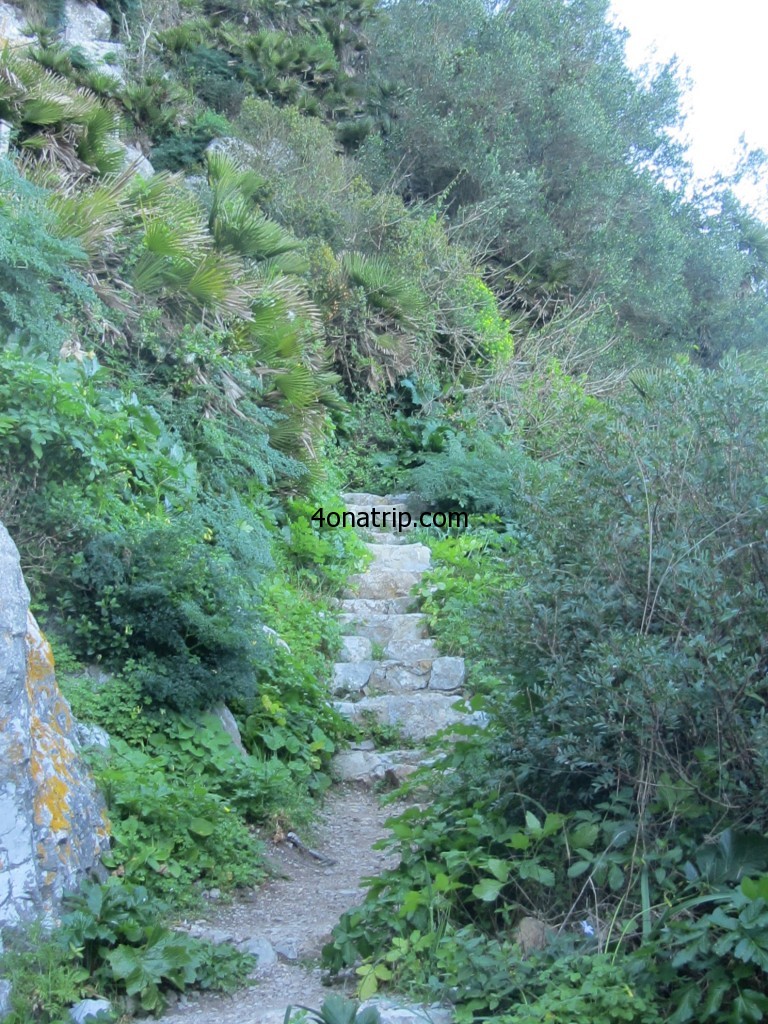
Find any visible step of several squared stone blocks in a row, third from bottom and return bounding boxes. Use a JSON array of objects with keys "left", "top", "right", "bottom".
[{"left": 331, "top": 657, "right": 466, "bottom": 697}]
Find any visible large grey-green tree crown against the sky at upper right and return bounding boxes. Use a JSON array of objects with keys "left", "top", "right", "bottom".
[{"left": 360, "top": 0, "right": 768, "bottom": 350}]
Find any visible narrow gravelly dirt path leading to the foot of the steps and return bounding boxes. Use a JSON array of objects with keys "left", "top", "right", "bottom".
[{"left": 160, "top": 787, "right": 405, "bottom": 1024}]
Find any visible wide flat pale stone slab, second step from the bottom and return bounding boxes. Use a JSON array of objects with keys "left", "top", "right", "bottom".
[{"left": 334, "top": 692, "right": 472, "bottom": 741}]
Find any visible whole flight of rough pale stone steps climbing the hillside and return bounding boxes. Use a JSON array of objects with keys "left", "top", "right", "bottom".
[{"left": 331, "top": 493, "right": 472, "bottom": 785}]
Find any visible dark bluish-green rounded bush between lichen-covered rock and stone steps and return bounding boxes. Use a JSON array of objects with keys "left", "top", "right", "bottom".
[{"left": 59, "top": 517, "right": 268, "bottom": 710}]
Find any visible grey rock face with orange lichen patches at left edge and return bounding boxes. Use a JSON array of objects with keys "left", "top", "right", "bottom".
[{"left": 0, "top": 524, "right": 109, "bottom": 925}]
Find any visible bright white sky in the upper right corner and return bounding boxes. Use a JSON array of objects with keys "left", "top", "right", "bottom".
[{"left": 611, "top": 0, "right": 768, "bottom": 206}]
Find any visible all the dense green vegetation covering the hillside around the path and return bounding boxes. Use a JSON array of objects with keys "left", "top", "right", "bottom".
[{"left": 0, "top": 0, "right": 768, "bottom": 1024}]
